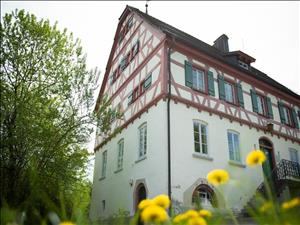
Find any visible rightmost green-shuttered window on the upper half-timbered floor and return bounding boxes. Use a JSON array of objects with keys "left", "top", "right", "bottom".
[{"left": 278, "top": 101, "right": 299, "bottom": 129}]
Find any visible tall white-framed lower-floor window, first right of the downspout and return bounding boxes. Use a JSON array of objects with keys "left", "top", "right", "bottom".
[{"left": 193, "top": 121, "right": 208, "bottom": 154}]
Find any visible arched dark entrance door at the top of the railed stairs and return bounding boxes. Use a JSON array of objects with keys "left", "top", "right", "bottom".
[{"left": 259, "top": 138, "right": 275, "bottom": 180}]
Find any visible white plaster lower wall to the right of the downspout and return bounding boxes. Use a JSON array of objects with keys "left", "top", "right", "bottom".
[{"left": 171, "top": 102, "right": 300, "bottom": 209}]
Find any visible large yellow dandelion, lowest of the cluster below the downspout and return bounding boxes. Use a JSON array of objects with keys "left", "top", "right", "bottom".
[{"left": 141, "top": 205, "right": 168, "bottom": 223}]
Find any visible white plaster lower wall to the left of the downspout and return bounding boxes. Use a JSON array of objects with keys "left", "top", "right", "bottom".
[{"left": 90, "top": 101, "right": 167, "bottom": 220}]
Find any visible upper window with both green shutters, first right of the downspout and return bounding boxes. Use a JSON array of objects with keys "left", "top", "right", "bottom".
[{"left": 185, "top": 61, "right": 215, "bottom": 96}]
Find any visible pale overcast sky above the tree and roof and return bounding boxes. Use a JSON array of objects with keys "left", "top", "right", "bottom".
[{"left": 1, "top": 1, "right": 300, "bottom": 178}]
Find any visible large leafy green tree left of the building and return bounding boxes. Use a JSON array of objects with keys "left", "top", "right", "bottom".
[{"left": 0, "top": 10, "right": 99, "bottom": 221}]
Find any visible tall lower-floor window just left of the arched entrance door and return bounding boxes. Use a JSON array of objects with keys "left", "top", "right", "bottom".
[{"left": 227, "top": 131, "right": 241, "bottom": 162}]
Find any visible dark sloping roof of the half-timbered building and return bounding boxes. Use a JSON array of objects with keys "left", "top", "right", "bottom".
[{"left": 127, "top": 6, "right": 300, "bottom": 99}]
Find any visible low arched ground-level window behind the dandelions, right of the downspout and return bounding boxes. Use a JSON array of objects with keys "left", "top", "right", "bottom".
[{"left": 192, "top": 184, "right": 217, "bottom": 208}]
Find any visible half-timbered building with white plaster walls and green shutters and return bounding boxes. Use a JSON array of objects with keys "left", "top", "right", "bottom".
[{"left": 90, "top": 6, "right": 300, "bottom": 219}]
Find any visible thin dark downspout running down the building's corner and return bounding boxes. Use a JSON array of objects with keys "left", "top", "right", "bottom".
[{"left": 167, "top": 41, "right": 172, "bottom": 203}]
